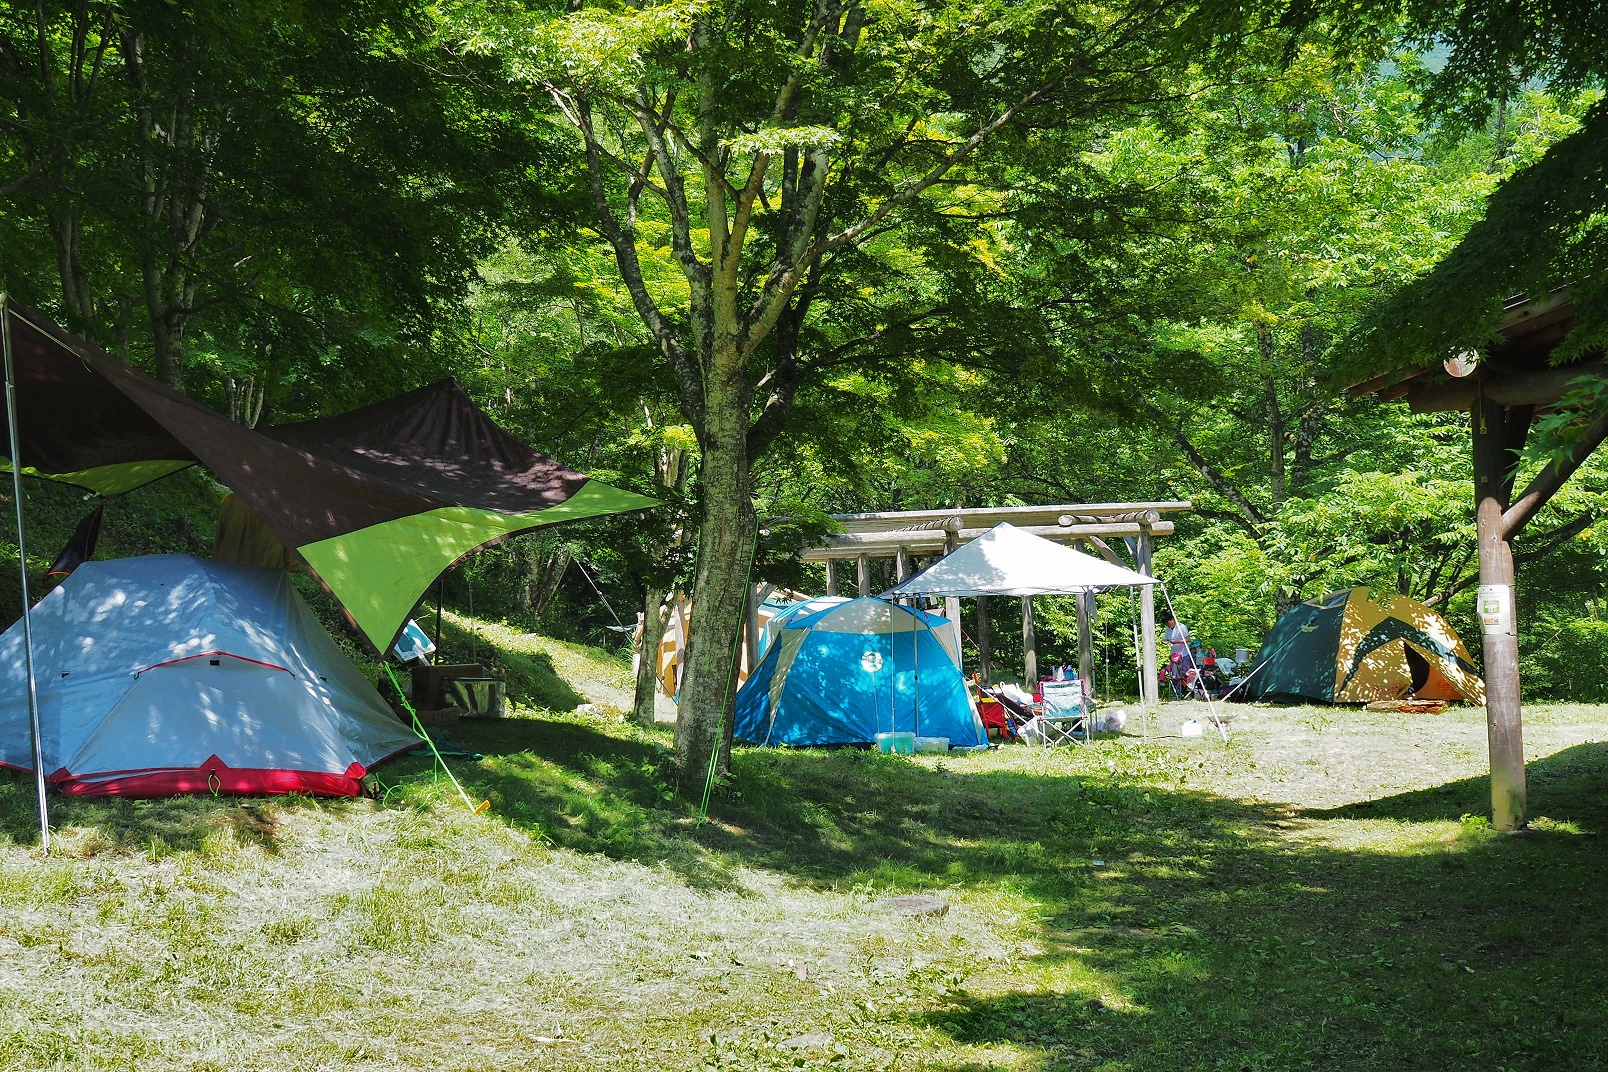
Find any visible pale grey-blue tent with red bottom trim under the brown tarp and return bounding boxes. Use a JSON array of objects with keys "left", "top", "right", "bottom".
[{"left": 0, "top": 554, "right": 418, "bottom": 797}]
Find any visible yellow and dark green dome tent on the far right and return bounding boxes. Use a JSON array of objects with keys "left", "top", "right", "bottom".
[{"left": 1249, "top": 588, "right": 1486, "bottom": 704}]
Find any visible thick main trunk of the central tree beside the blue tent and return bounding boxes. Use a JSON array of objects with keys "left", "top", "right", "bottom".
[{"left": 675, "top": 350, "right": 754, "bottom": 784}]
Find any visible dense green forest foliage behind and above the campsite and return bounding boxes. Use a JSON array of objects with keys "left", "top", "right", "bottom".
[{"left": 0, "top": 0, "right": 1608, "bottom": 742}]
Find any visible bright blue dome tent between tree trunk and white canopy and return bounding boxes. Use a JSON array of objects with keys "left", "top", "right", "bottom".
[{"left": 735, "top": 598, "right": 987, "bottom": 747}]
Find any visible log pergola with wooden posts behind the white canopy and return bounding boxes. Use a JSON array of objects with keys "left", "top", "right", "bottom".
[{"left": 801, "top": 501, "right": 1193, "bottom": 707}]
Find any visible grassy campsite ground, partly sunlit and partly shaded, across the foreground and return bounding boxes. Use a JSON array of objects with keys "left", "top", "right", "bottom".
[{"left": 0, "top": 627, "right": 1608, "bottom": 1072}]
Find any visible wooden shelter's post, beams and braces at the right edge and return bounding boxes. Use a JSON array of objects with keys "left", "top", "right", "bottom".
[{"left": 1351, "top": 291, "right": 1608, "bottom": 829}]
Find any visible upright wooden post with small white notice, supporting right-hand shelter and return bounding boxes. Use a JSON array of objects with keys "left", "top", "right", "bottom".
[{"left": 1470, "top": 397, "right": 1532, "bottom": 829}]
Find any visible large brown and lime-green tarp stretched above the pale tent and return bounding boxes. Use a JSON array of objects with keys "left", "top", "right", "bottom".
[{"left": 0, "top": 297, "right": 658, "bottom": 651}]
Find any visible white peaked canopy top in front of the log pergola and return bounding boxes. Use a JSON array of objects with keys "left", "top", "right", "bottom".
[{"left": 883, "top": 522, "right": 1158, "bottom": 599}]
